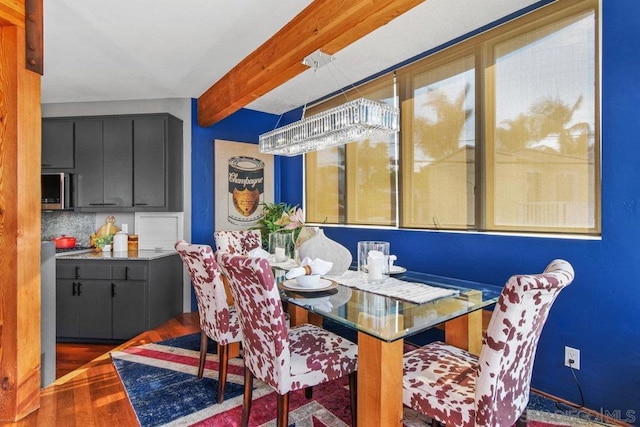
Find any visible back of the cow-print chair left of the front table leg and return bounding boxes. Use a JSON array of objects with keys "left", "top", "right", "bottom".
[{"left": 216, "top": 252, "right": 291, "bottom": 394}]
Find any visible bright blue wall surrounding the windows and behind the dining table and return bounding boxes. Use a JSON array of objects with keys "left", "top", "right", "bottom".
[{"left": 192, "top": 0, "right": 640, "bottom": 424}]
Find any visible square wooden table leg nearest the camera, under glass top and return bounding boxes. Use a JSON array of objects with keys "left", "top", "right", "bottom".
[{"left": 358, "top": 332, "right": 404, "bottom": 427}]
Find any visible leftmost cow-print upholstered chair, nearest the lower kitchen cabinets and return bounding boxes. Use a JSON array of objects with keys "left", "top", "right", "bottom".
[{"left": 175, "top": 240, "right": 242, "bottom": 403}]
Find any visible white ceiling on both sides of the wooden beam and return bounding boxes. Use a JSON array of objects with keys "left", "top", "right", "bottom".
[{"left": 42, "top": 0, "right": 538, "bottom": 114}]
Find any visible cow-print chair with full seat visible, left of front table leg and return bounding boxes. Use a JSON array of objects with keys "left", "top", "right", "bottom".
[{"left": 216, "top": 252, "right": 358, "bottom": 426}]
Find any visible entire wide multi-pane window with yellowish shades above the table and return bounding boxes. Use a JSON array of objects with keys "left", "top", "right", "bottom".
[{"left": 305, "top": 0, "right": 600, "bottom": 234}]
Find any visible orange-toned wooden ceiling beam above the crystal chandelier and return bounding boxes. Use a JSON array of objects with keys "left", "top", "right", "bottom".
[{"left": 198, "top": 0, "right": 424, "bottom": 126}]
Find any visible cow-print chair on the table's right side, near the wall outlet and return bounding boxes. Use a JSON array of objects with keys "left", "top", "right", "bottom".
[{"left": 403, "top": 260, "right": 574, "bottom": 427}]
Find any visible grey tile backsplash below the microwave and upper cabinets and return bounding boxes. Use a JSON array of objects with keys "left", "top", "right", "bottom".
[{"left": 42, "top": 211, "right": 96, "bottom": 246}]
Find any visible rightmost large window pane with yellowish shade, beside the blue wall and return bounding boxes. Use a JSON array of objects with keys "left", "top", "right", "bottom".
[{"left": 486, "top": 7, "right": 599, "bottom": 232}]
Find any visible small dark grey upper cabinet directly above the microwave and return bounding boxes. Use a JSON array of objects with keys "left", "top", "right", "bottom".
[{"left": 42, "top": 119, "right": 74, "bottom": 170}]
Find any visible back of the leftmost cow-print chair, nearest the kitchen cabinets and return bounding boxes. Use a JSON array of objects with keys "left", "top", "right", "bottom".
[{"left": 175, "top": 240, "right": 240, "bottom": 345}]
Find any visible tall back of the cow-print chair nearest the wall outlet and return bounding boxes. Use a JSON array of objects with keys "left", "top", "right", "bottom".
[{"left": 475, "top": 259, "right": 574, "bottom": 426}]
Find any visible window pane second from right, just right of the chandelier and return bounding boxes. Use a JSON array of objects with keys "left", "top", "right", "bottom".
[{"left": 398, "top": 52, "right": 476, "bottom": 229}]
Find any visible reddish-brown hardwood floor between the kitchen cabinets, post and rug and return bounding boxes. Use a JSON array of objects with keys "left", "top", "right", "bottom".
[{"left": 0, "top": 312, "right": 200, "bottom": 427}]
